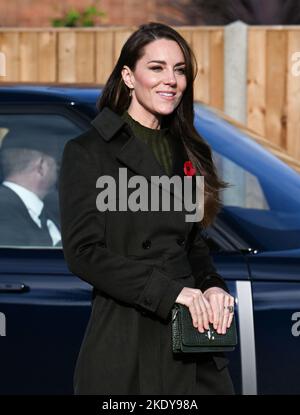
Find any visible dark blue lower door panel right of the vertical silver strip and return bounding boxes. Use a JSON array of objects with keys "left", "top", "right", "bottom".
[{"left": 249, "top": 249, "right": 300, "bottom": 395}]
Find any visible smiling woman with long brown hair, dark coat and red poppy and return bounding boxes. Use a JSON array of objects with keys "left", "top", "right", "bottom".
[{"left": 59, "top": 23, "right": 234, "bottom": 394}]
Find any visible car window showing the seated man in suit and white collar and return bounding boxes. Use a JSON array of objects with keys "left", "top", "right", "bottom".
[{"left": 0, "top": 113, "right": 82, "bottom": 247}]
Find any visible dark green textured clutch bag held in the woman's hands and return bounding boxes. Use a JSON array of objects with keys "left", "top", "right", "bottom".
[{"left": 172, "top": 303, "right": 237, "bottom": 353}]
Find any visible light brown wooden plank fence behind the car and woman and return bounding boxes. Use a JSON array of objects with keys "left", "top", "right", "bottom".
[{"left": 0, "top": 26, "right": 300, "bottom": 164}]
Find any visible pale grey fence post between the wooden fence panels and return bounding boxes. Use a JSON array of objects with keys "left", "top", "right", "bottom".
[{"left": 224, "top": 21, "right": 248, "bottom": 125}]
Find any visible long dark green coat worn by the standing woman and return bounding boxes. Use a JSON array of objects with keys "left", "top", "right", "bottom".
[{"left": 59, "top": 108, "right": 232, "bottom": 395}]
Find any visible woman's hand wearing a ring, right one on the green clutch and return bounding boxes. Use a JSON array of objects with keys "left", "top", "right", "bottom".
[{"left": 203, "top": 287, "right": 234, "bottom": 334}]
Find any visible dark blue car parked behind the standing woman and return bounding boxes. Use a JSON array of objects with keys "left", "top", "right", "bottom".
[{"left": 0, "top": 86, "right": 300, "bottom": 394}]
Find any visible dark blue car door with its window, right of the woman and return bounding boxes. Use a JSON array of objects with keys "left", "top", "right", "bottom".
[{"left": 210, "top": 135, "right": 300, "bottom": 394}]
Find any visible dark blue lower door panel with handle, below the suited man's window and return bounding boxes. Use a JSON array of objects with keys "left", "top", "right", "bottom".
[{"left": 0, "top": 248, "right": 91, "bottom": 394}]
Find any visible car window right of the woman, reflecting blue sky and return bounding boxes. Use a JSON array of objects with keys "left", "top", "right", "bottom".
[{"left": 213, "top": 151, "right": 300, "bottom": 250}]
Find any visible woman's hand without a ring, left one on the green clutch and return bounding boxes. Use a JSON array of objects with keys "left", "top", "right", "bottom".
[{"left": 175, "top": 287, "right": 213, "bottom": 333}]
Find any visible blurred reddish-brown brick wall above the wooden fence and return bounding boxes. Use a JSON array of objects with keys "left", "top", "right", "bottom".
[{"left": 0, "top": 0, "right": 202, "bottom": 27}]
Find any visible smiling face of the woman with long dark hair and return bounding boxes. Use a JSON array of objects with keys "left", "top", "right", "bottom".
[{"left": 122, "top": 39, "right": 186, "bottom": 128}]
